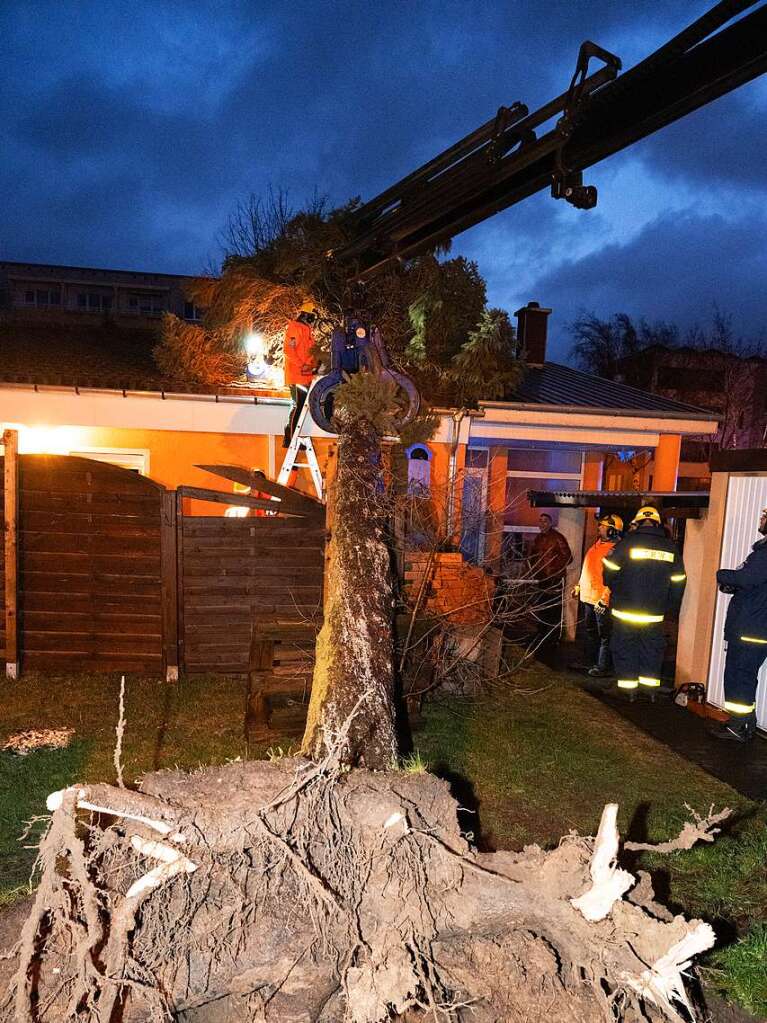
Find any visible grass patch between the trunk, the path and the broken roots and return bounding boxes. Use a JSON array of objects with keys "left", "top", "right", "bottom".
[{"left": 416, "top": 669, "right": 751, "bottom": 849}]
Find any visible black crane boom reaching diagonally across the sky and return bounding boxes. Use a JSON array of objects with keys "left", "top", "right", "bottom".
[{"left": 332, "top": 0, "right": 767, "bottom": 281}]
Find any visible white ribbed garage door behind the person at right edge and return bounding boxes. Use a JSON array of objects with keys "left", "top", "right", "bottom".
[{"left": 708, "top": 476, "right": 767, "bottom": 728}]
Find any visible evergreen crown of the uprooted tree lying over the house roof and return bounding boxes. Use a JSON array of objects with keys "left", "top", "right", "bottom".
[{"left": 154, "top": 192, "right": 516, "bottom": 403}]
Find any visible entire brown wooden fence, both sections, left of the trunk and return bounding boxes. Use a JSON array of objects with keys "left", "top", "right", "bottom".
[{"left": 0, "top": 441, "right": 325, "bottom": 694}]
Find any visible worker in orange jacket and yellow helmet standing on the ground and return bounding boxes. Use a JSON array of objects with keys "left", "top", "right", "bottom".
[{"left": 571, "top": 515, "right": 623, "bottom": 678}]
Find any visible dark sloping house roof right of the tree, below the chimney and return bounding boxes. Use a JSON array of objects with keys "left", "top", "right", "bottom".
[{"left": 481, "top": 362, "right": 716, "bottom": 420}]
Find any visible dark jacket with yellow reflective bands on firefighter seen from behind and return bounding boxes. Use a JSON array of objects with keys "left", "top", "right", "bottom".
[{"left": 602, "top": 523, "right": 687, "bottom": 624}]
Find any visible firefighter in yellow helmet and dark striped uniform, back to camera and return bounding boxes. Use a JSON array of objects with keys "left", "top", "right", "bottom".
[{"left": 602, "top": 505, "right": 687, "bottom": 700}]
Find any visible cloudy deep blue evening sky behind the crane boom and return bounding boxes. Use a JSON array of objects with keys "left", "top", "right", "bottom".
[{"left": 0, "top": 0, "right": 767, "bottom": 358}]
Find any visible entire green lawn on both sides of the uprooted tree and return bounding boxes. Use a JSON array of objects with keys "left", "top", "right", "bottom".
[{"left": 0, "top": 666, "right": 767, "bottom": 1017}]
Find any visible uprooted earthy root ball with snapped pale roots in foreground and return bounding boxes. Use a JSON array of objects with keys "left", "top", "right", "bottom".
[{"left": 0, "top": 758, "right": 719, "bottom": 1023}]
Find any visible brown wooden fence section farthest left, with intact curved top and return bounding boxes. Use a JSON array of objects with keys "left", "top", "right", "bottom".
[{"left": 0, "top": 454, "right": 165, "bottom": 673}]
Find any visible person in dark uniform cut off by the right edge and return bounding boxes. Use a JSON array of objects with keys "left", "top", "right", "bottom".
[{"left": 711, "top": 508, "right": 767, "bottom": 743}]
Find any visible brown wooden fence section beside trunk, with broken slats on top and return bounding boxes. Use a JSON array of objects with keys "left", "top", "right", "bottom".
[{"left": 178, "top": 466, "right": 325, "bottom": 692}]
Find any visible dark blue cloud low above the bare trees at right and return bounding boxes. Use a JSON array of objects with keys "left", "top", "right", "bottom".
[{"left": 533, "top": 213, "right": 767, "bottom": 359}]
